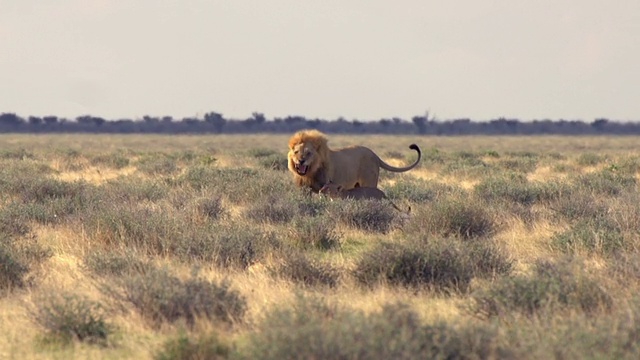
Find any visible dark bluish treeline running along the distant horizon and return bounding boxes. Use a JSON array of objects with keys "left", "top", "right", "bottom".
[{"left": 0, "top": 112, "right": 640, "bottom": 135}]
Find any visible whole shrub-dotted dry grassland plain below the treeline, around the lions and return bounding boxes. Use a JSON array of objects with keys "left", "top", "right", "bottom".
[{"left": 0, "top": 135, "right": 640, "bottom": 359}]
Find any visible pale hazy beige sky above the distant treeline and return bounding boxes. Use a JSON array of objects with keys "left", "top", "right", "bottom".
[{"left": 0, "top": 0, "right": 640, "bottom": 121}]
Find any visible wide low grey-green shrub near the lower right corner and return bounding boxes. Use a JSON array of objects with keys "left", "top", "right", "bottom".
[{"left": 471, "top": 260, "right": 612, "bottom": 316}]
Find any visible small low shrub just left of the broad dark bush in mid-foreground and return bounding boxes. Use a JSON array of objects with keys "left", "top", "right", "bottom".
[{"left": 277, "top": 251, "right": 340, "bottom": 287}]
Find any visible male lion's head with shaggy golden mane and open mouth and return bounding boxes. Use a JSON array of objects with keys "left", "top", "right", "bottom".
[{"left": 287, "top": 130, "right": 329, "bottom": 178}]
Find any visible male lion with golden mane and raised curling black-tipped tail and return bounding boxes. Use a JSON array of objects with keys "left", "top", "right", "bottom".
[{"left": 287, "top": 130, "right": 422, "bottom": 192}]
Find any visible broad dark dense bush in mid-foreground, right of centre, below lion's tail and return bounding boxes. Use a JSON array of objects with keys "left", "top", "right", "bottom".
[{"left": 354, "top": 241, "right": 475, "bottom": 291}]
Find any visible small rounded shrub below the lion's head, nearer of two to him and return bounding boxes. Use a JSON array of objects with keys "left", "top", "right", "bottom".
[{"left": 288, "top": 216, "right": 342, "bottom": 250}]
